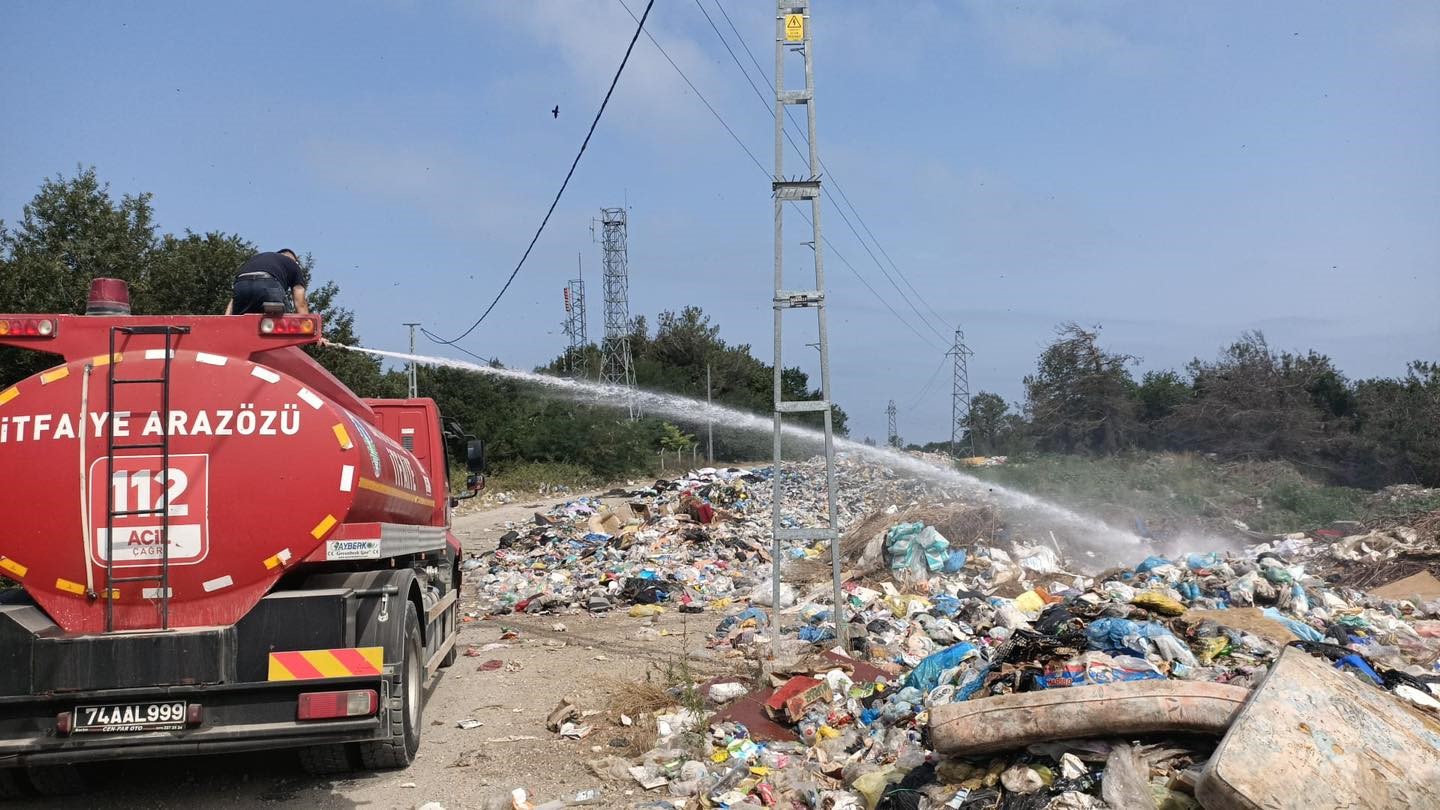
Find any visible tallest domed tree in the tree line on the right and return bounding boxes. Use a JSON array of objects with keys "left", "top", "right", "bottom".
[{"left": 1024, "top": 323, "right": 1136, "bottom": 454}]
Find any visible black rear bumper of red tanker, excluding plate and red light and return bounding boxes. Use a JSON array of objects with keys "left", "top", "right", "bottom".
[{"left": 0, "top": 677, "right": 389, "bottom": 768}]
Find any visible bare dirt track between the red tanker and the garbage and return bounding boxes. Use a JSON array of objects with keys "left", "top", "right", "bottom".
[{"left": 4, "top": 500, "right": 733, "bottom": 810}]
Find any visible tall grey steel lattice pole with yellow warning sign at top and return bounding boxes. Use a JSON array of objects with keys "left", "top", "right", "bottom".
[{"left": 769, "top": 0, "right": 850, "bottom": 657}]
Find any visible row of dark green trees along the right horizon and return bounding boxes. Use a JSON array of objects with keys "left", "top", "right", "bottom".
[{"left": 990, "top": 324, "right": 1440, "bottom": 484}]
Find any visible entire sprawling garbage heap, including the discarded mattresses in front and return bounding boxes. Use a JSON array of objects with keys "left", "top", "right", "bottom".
[{"left": 460, "top": 458, "right": 1440, "bottom": 810}]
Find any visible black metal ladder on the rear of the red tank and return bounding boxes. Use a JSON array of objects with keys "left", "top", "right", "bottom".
[{"left": 104, "top": 326, "right": 190, "bottom": 633}]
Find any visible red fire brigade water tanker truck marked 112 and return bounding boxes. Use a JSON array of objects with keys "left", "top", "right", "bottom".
[{"left": 0, "top": 285, "right": 482, "bottom": 797}]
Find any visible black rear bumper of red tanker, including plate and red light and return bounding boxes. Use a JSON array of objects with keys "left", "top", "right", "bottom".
[{"left": 0, "top": 675, "right": 390, "bottom": 768}]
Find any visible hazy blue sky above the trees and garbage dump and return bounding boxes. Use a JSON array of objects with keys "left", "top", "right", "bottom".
[{"left": 0, "top": 0, "right": 1440, "bottom": 442}]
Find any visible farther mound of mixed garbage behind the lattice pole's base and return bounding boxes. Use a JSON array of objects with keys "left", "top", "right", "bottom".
[{"left": 467, "top": 458, "right": 932, "bottom": 617}]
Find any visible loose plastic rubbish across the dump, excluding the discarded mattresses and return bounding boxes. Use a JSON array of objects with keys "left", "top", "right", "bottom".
[{"left": 467, "top": 457, "right": 1440, "bottom": 810}]
